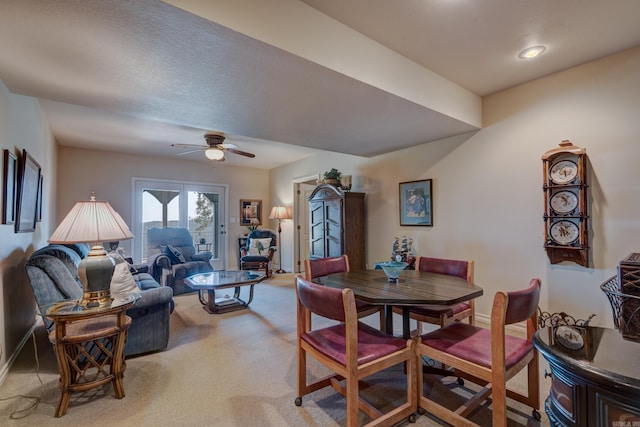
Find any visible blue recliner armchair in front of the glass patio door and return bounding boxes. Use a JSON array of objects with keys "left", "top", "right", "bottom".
[{"left": 147, "top": 228, "right": 213, "bottom": 295}]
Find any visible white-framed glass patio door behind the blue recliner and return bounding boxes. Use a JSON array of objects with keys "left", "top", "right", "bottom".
[{"left": 133, "top": 178, "right": 227, "bottom": 270}]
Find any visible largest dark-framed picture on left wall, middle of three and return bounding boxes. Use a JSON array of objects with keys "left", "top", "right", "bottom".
[{"left": 15, "top": 150, "right": 40, "bottom": 233}]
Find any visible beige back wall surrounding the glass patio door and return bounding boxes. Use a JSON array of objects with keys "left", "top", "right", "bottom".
[{"left": 54, "top": 147, "right": 270, "bottom": 267}]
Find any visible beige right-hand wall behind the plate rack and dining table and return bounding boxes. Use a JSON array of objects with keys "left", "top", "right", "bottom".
[{"left": 271, "top": 48, "right": 640, "bottom": 326}]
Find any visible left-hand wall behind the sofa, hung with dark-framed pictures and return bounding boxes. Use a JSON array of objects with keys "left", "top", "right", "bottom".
[{"left": 0, "top": 80, "right": 56, "bottom": 381}]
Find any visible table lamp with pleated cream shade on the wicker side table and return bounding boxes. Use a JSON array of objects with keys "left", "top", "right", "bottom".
[{"left": 49, "top": 193, "right": 133, "bottom": 307}]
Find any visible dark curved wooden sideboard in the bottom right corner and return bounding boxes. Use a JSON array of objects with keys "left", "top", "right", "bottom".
[{"left": 533, "top": 326, "right": 640, "bottom": 427}]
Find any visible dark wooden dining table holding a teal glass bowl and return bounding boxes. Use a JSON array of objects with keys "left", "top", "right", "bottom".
[{"left": 316, "top": 270, "right": 483, "bottom": 339}]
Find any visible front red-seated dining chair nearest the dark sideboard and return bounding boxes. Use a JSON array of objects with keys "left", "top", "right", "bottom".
[{"left": 416, "top": 279, "right": 540, "bottom": 427}]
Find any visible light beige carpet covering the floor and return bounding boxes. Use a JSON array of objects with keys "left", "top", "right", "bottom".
[{"left": 0, "top": 274, "right": 548, "bottom": 427}]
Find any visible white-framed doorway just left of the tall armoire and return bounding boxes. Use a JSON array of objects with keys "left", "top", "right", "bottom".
[{"left": 293, "top": 175, "right": 320, "bottom": 274}]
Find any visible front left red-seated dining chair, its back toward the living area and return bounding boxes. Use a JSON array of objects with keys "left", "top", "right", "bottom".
[{"left": 295, "top": 276, "right": 417, "bottom": 427}]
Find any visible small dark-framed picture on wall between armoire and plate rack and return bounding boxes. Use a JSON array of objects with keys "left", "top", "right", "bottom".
[{"left": 400, "top": 179, "right": 433, "bottom": 227}]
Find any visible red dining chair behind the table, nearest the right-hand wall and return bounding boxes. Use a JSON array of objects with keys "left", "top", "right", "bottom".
[{"left": 404, "top": 257, "right": 475, "bottom": 334}]
